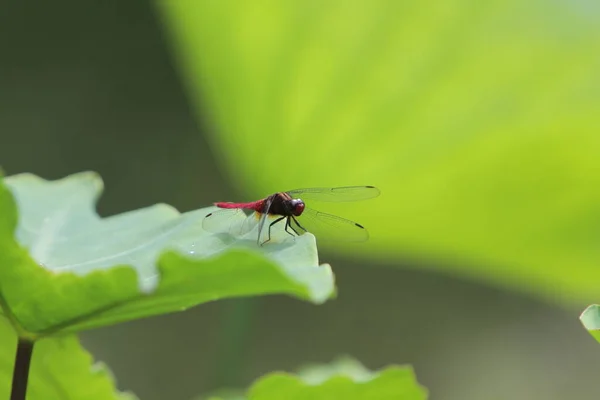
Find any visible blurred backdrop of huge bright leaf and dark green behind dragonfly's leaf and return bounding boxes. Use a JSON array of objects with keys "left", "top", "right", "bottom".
[{"left": 0, "top": 0, "right": 600, "bottom": 400}]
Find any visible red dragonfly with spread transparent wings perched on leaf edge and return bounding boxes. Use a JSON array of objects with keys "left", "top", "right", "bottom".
[{"left": 202, "top": 186, "right": 380, "bottom": 246}]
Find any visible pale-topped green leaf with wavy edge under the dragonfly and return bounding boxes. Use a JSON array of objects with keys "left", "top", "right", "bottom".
[{"left": 0, "top": 172, "right": 335, "bottom": 338}]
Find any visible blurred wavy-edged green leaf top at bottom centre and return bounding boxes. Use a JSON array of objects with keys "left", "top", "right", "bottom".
[{"left": 197, "top": 357, "right": 428, "bottom": 400}]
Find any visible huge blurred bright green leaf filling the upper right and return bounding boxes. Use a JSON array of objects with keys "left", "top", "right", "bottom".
[{"left": 160, "top": 0, "right": 600, "bottom": 301}]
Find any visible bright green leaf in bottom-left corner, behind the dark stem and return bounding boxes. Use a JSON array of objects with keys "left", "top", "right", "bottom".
[{"left": 0, "top": 317, "right": 137, "bottom": 400}]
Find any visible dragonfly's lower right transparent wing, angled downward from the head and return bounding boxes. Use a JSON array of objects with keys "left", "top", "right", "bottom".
[{"left": 291, "top": 208, "right": 369, "bottom": 242}]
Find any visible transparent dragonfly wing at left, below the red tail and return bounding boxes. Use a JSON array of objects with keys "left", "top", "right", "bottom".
[{"left": 202, "top": 208, "right": 260, "bottom": 237}]
